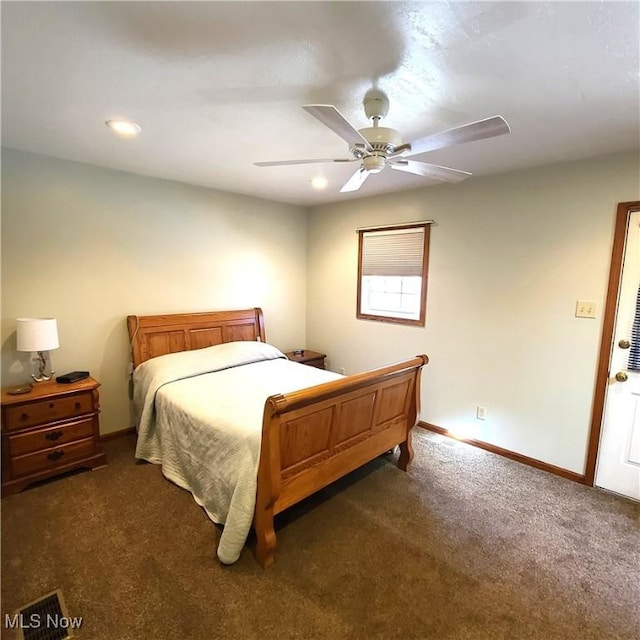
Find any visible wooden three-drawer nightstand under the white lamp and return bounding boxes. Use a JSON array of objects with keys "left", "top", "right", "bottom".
[{"left": 2, "top": 378, "right": 107, "bottom": 496}]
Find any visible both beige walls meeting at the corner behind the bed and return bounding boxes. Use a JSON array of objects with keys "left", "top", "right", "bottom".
[{"left": 2, "top": 150, "right": 640, "bottom": 473}]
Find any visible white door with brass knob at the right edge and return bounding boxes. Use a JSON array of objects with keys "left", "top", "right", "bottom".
[{"left": 595, "top": 211, "right": 640, "bottom": 500}]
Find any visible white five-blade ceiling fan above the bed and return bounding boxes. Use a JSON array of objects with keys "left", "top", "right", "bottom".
[{"left": 254, "top": 89, "right": 511, "bottom": 193}]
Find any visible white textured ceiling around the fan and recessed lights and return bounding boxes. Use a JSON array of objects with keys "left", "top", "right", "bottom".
[{"left": 1, "top": 1, "right": 640, "bottom": 205}]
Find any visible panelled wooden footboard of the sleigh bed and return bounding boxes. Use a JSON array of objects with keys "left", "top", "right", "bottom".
[{"left": 254, "top": 355, "right": 429, "bottom": 568}]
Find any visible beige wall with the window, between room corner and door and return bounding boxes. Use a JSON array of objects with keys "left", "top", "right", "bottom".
[{"left": 307, "top": 154, "right": 640, "bottom": 473}]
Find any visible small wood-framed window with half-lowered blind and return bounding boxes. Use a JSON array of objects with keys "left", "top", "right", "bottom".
[{"left": 356, "top": 222, "right": 429, "bottom": 326}]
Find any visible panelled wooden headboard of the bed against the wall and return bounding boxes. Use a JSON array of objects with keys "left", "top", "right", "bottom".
[{"left": 127, "top": 307, "right": 266, "bottom": 367}]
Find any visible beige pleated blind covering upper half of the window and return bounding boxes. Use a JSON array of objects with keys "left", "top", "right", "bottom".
[{"left": 361, "top": 227, "right": 424, "bottom": 276}]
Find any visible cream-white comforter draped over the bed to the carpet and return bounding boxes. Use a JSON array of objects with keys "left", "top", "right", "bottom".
[{"left": 134, "top": 341, "right": 341, "bottom": 564}]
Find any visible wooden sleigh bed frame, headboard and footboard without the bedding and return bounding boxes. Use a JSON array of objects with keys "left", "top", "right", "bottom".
[{"left": 127, "top": 308, "right": 428, "bottom": 568}]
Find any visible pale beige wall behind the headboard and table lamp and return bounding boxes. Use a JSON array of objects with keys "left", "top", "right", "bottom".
[{"left": 1, "top": 150, "right": 306, "bottom": 433}]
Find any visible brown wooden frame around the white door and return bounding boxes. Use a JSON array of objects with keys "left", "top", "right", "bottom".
[{"left": 584, "top": 200, "right": 640, "bottom": 487}]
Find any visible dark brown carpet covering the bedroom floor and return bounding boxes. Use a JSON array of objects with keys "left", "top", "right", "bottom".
[{"left": 2, "top": 429, "right": 640, "bottom": 640}]
